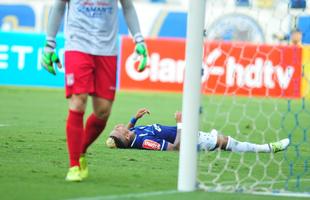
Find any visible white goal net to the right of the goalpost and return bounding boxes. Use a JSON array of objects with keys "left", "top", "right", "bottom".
[{"left": 198, "top": 0, "right": 310, "bottom": 196}]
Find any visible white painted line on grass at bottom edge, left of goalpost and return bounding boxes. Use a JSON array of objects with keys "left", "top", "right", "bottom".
[{"left": 68, "top": 190, "right": 178, "bottom": 200}]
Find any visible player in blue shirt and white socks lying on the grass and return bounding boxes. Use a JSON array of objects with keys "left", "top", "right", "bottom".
[{"left": 106, "top": 108, "right": 290, "bottom": 153}]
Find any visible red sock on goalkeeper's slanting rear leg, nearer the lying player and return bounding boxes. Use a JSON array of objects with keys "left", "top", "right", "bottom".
[{"left": 82, "top": 113, "right": 107, "bottom": 154}]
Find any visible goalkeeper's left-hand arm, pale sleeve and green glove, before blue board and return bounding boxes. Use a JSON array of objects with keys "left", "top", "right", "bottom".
[{"left": 41, "top": 0, "right": 67, "bottom": 75}]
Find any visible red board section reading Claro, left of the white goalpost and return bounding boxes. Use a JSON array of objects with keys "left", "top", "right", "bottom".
[{"left": 120, "top": 37, "right": 185, "bottom": 92}]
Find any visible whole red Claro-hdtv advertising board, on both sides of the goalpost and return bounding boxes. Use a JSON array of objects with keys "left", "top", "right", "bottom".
[{"left": 120, "top": 38, "right": 301, "bottom": 98}]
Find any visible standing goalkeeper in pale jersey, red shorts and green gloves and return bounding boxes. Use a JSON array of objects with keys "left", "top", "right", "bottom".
[{"left": 41, "top": 0, "right": 147, "bottom": 181}]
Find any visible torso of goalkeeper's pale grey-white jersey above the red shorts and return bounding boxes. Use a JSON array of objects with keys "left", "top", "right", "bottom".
[{"left": 65, "top": 0, "right": 118, "bottom": 55}]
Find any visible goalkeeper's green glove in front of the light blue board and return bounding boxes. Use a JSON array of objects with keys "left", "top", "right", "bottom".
[{"left": 41, "top": 38, "right": 62, "bottom": 75}]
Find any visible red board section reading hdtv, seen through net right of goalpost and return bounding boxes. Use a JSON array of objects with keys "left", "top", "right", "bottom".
[{"left": 203, "top": 42, "right": 301, "bottom": 98}]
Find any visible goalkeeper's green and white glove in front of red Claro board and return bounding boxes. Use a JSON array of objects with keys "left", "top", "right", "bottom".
[{"left": 134, "top": 33, "right": 147, "bottom": 72}]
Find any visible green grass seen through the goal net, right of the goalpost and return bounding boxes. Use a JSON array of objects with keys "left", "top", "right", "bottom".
[{"left": 199, "top": 96, "right": 310, "bottom": 192}]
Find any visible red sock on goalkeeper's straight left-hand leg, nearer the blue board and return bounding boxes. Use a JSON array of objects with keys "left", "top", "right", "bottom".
[{"left": 66, "top": 110, "right": 84, "bottom": 167}]
